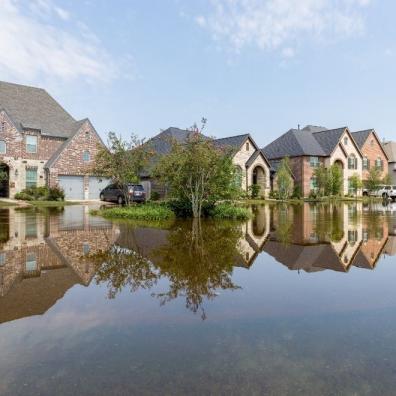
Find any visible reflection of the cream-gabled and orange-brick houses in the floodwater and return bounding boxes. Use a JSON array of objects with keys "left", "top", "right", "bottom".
[{"left": 263, "top": 203, "right": 388, "bottom": 272}]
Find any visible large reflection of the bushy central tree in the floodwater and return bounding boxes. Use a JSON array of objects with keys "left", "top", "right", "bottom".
[{"left": 155, "top": 219, "right": 241, "bottom": 319}]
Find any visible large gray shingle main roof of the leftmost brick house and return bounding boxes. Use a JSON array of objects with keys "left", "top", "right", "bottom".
[{"left": 0, "top": 81, "right": 78, "bottom": 138}]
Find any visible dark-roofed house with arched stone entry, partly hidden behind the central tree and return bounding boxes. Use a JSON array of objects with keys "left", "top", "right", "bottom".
[{"left": 141, "top": 127, "right": 270, "bottom": 196}]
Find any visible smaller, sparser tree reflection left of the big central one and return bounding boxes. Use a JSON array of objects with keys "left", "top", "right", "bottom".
[{"left": 92, "top": 246, "right": 159, "bottom": 298}]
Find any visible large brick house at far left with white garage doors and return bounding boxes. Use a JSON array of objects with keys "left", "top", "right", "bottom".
[{"left": 0, "top": 82, "right": 107, "bottom": 200}]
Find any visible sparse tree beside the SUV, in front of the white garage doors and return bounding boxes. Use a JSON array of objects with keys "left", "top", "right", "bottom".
[{"left": 91, "top": 132, "right": 152, "bottom": 202}]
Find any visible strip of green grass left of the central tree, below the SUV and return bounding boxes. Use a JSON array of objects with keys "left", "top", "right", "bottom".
[{"left": 90, "top": 204, "right": 175, "bottom": 221}]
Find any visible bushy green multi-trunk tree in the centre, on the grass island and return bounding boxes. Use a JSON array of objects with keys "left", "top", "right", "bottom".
[{"left": 154, "top": 128, "right": 240, "bottom": 218}]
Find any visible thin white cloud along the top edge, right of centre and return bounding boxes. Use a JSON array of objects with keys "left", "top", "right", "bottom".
[{"left": 196, "top": 0, "right": 370, "bottom": 56}]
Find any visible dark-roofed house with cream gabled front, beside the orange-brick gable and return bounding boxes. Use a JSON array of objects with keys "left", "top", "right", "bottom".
[{"left": 262, "top": 125, "right": 363, "bottom": 196}]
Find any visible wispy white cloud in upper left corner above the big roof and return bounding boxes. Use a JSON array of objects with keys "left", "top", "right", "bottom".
[{"left": 0, "top": 0, "right": 118, "bottom": 82}]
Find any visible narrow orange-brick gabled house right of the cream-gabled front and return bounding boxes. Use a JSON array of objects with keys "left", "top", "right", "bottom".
[{"left": 352, "top": 129, "right": 388, "bottom": 181}]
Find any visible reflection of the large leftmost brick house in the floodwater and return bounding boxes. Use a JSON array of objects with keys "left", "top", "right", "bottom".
[{"left": 0, "top": 206, "right": 118, "bottom": 323}]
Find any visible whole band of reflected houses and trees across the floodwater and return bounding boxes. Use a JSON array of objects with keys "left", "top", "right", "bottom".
[{"left": 0, "top": 202, "right": 396, "bottom": 323}]
